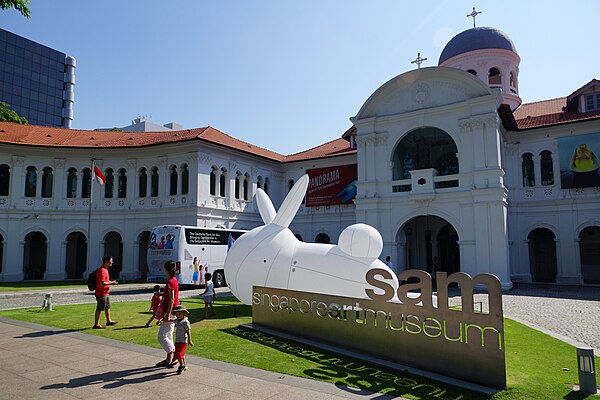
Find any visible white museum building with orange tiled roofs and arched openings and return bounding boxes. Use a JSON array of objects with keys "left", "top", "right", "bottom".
[{"left": 0, "top": 27, "right": 600, "bottom": 289}]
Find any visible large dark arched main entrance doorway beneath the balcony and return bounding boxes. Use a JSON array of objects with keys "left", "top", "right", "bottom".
[{"left": 397, "top": 215, "right": 460, "bottom": 278}]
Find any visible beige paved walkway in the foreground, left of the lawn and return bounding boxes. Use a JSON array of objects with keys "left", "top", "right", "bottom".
[{"left": 0, "top": 318, "right": 404, "bottom": 400}]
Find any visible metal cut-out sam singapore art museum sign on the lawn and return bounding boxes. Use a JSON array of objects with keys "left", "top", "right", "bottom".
[{"left": 252, "top": 269, "right": 506, "bottom": 388}]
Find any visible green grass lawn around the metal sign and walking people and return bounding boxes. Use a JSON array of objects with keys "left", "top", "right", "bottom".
[{"left": 0, "top": 298, "right": 600, "bottom": 400}]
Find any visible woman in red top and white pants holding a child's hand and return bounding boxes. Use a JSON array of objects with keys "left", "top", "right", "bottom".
[{"left": 156, "top": 261, "right": 179, "bottom": 368}]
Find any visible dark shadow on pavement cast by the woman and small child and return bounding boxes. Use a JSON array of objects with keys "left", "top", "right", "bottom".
[{"left": 40, "top": 367, "right": 174, "bottom": 390}]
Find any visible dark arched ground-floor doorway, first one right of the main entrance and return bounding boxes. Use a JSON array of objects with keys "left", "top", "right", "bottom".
[{"left": 527, "top": 228, "right": 557, "bottom": 283}]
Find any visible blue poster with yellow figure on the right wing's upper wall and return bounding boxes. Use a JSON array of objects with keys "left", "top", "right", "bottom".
[{"left": 558, "top": 133, "right": 600, "bottom": 189}]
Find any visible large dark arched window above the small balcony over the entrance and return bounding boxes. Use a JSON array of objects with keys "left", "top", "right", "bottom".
[{"left": 392, "top": 127, "right": 459, "bottom": 180}]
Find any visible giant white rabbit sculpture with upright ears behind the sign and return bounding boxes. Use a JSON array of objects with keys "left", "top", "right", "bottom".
[{"left": 225, "top": 175, "right": 398, "bottom": 305}]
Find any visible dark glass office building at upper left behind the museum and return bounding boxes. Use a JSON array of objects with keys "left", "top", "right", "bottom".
[{"left": 0, "top": 29, "right": 75, "bottom": 128}]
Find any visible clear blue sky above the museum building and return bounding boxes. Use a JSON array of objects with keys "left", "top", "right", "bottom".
[{"left": 0, "top": 0, "right": 600, "bottom": 154}]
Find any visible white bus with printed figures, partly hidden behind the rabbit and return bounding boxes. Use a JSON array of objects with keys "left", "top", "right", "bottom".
[{"left": 148, "top": 225, "right": 245, "bottom": 287}]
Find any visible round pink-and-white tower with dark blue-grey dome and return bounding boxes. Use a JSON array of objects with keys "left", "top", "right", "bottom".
[{"left": 438, "top": 27, "right": 521, "bottom": 110}]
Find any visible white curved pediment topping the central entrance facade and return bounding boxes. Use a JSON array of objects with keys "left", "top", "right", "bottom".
[{"left": 355, "top": 67, "right": 491, "bottom": 119}]
